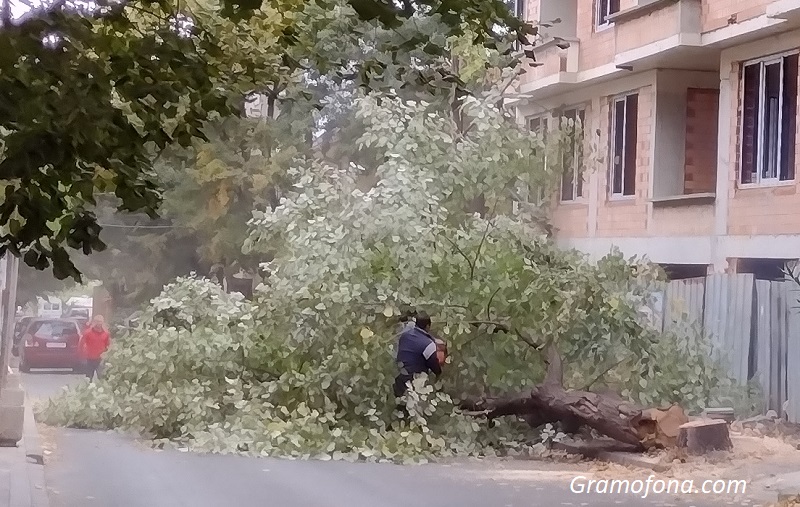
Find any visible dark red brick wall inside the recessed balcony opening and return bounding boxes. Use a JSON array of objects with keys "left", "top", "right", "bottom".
[{"left": 683, "top": 88, "right": 719, "bottom": 194}]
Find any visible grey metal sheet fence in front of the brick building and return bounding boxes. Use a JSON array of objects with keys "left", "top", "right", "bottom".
[{"left": 655, "top": 274, "right": 800, "bottom": 423}]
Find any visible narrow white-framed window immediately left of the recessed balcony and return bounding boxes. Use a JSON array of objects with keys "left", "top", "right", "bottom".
[{"left": 611, "top": 94, "right": 639, "bottom": 195}]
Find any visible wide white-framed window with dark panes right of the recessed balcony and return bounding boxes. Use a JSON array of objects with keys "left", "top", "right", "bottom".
[{"left": 741, "top": 54, "right": 798, "bottom": 184}]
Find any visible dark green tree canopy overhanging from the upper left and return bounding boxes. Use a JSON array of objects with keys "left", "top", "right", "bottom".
[{"left": 0, "top": 0, "right": 534, "bottom": 278}]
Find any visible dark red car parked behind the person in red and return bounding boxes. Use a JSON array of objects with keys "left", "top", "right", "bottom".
[{"left": 19, "top": 318, "right": 82, "bottom": 372}]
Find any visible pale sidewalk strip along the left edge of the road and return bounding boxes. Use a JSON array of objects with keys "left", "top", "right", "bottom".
[{"left": 0, "top": 374, "right": 50, "bottom": 507}]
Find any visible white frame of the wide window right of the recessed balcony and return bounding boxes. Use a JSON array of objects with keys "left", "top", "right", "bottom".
[{"left": 736, "top": 49, "right": 800, "bottom": 188}]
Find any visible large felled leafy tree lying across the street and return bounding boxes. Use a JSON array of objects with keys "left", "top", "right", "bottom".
[{"left": 37, "top": 90, "right": 736, "bottom": 460}]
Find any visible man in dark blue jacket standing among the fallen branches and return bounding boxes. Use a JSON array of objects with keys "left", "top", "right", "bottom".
[{"left": 394, "top": 313, "right": 442, "bottom": 397}]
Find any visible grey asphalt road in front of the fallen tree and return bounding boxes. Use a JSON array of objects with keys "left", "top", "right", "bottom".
[{"left": 23, "top": 372, "right": 752, "bottom": 507}]
